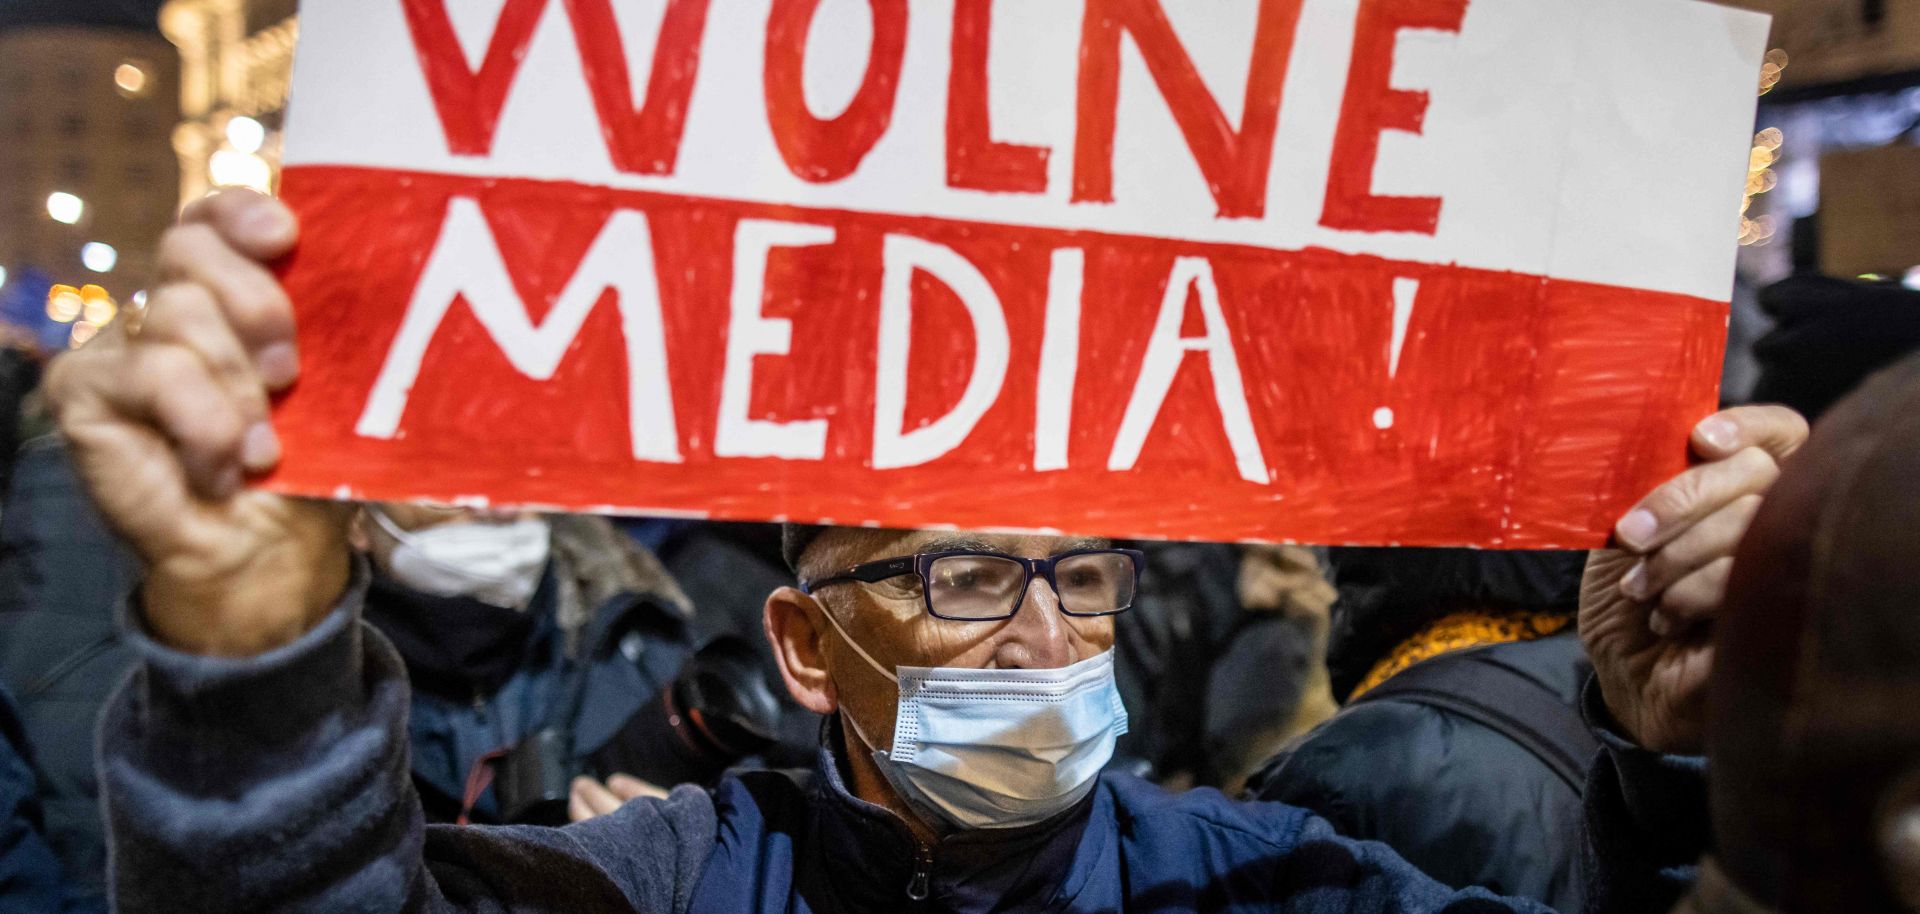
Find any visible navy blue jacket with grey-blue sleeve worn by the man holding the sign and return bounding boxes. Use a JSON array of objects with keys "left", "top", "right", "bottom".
[{"left": 102, "top": 572, "right": 1701, "bottom": 914}]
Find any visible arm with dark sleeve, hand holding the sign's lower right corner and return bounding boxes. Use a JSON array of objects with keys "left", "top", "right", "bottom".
[{"left": 1580, "top": 407, "right": 1807, "bottom": 914}]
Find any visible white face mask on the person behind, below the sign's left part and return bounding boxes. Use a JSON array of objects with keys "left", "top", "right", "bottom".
[{"left": 367, "top": 507, "right": 553, "bottom": 609}]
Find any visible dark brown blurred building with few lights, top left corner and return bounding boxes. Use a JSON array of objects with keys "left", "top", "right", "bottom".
[{"left": 0, "top": 25, "right": 179, "bottom": 338}]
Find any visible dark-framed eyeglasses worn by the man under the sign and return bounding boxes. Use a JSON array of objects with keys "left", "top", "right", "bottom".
[{"left": 801, "top": 549, "right": 1146, "bottom": 622}]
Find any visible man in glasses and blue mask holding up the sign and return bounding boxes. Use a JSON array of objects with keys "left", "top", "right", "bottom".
[{"left": 50, "top": 194, "right": 1805, "bottom": 914}]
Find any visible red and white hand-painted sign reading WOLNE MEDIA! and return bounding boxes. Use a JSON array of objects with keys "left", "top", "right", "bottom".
[{"left": 269, "top": 0, "right": 1766, "bottom": 547}]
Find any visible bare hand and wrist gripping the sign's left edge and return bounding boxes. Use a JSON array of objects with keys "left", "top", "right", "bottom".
[{"left": 46, "top": 190, "right": 351, "bottom": 657}]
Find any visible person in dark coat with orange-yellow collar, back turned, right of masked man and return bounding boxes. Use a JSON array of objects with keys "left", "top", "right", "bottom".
[{"left": 1252, "top": 547, "right": 1599, "bottom": 910}]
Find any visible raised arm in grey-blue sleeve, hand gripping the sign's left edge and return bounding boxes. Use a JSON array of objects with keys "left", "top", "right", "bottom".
[{"left": 58, "top": 192, "right": 712, "bottom": 914}]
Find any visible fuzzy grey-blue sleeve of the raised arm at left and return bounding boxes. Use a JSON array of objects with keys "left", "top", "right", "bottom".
[{"left": 98, "top": 568, "right": 714, "bottom": 914}]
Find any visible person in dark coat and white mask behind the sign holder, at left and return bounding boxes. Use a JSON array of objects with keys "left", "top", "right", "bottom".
[{"left": 355, "top": 505, "right": 718, "bottom": 824}]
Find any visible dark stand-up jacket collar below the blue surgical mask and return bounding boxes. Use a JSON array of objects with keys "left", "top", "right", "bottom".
[{"left": 801, "top": 716, "right": 1114, "bottom": 912}]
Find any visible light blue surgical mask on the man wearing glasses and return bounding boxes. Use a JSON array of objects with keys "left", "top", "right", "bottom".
[{"left": 822, "top": 609, "right": 1127, "bottom": 830}]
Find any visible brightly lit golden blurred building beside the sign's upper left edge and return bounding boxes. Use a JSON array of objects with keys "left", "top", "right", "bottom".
[{"left": 159, "top": 0, "right": 300, "bottom": 202}]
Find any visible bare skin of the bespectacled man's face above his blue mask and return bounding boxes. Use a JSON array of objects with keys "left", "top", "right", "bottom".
[{"left": 806, "top": 528, "right": 1116, "bottom": 749}]
